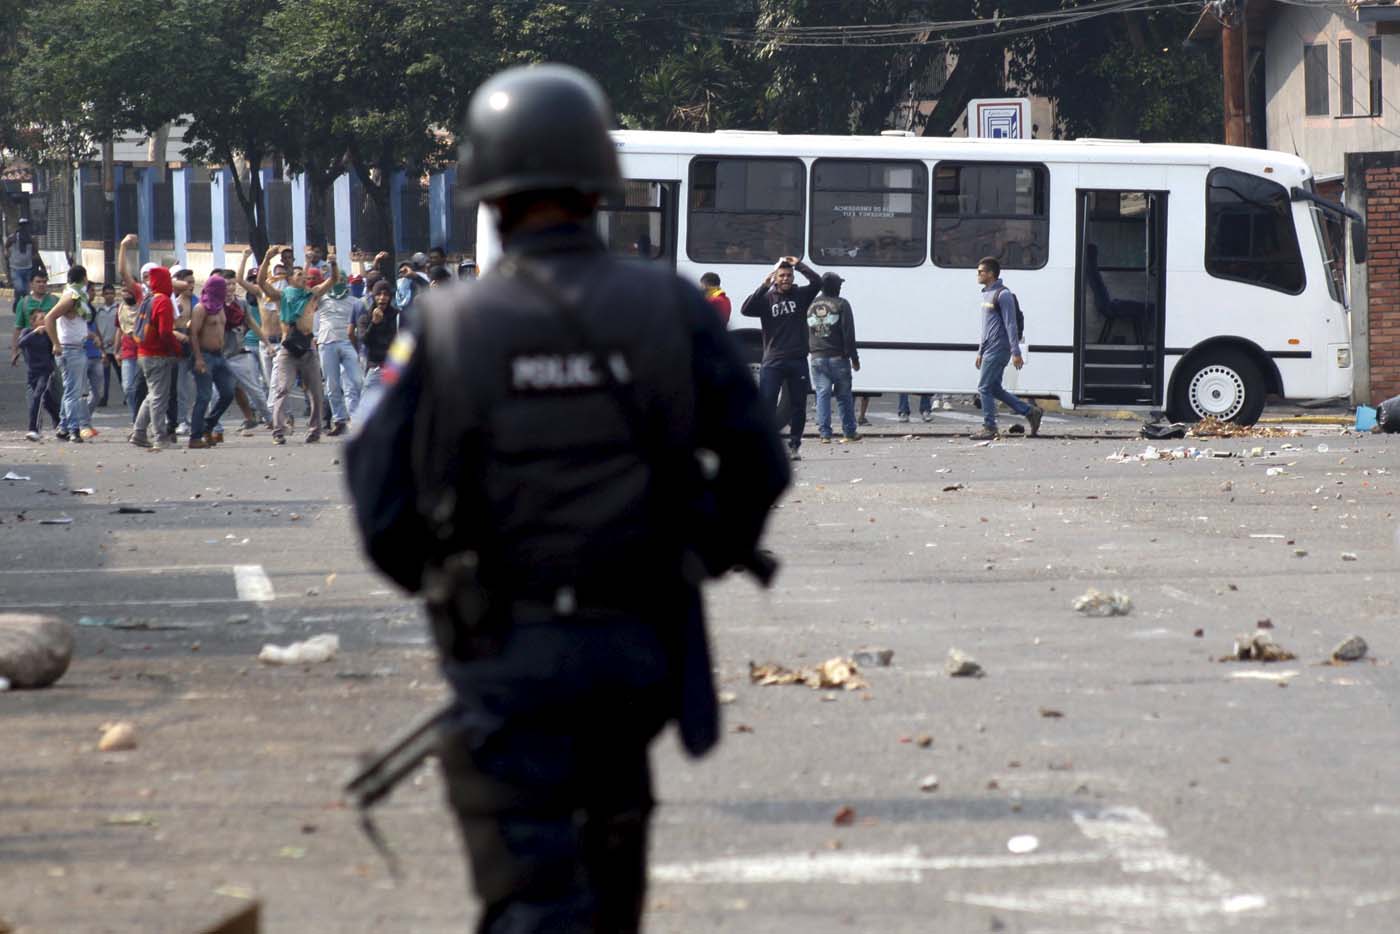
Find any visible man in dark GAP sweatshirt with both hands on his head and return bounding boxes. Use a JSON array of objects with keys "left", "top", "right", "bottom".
[{"left": 739, "top": 256, "right": 822, "bottom": 461}]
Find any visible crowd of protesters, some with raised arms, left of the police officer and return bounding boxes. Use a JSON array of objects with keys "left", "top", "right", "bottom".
[{"left": 7, "top": 234, "right": 470, "bottom": 449}]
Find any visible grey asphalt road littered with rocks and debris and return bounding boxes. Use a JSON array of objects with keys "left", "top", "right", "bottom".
[{"left": 0, "top": 331, "right": 1400, "bottom": 934}]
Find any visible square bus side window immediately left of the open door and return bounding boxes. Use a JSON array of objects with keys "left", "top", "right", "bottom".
[{"left": 932, "top": 162, "right": 1050, "bottom": 269}]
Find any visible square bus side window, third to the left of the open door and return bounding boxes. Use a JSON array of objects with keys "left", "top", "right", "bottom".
[{"left": 686, "top": 157, "right": 806, "bottom": 265}]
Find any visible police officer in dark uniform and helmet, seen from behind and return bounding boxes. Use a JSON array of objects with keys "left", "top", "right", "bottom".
[{"left": 347, "top": 66, "right": 788, "bottom": 933}]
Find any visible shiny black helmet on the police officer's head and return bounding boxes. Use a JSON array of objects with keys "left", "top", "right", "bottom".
[{"left": 458, "top": 64, "right": 622, "bottom": 200}]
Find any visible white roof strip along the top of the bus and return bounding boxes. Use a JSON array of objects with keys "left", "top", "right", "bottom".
[{"left": 613, "top": 130, "right": 1312, "bottom": 185}]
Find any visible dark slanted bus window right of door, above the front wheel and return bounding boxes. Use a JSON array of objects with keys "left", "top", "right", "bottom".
[{"left": 1205, "top": 168, "right": 1306, "bottom": 294}]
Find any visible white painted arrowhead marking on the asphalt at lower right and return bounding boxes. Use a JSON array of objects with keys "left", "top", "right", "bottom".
[{"left": 948, "top": 807, "right": 1268, "bottom": 934}]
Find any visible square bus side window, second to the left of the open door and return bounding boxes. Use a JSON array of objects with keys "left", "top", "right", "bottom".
[{"left": 811, "top": 158, "right": 928, "bottom": 266}]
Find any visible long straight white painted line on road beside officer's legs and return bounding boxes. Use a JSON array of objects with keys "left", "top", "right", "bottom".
[{"left": 651, "top": 847, "right": 1106, "bottom": 885}]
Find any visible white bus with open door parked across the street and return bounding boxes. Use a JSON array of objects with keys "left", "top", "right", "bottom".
[{"left": 483, "top": 130, "right": 1365, "bottom": 423}]
